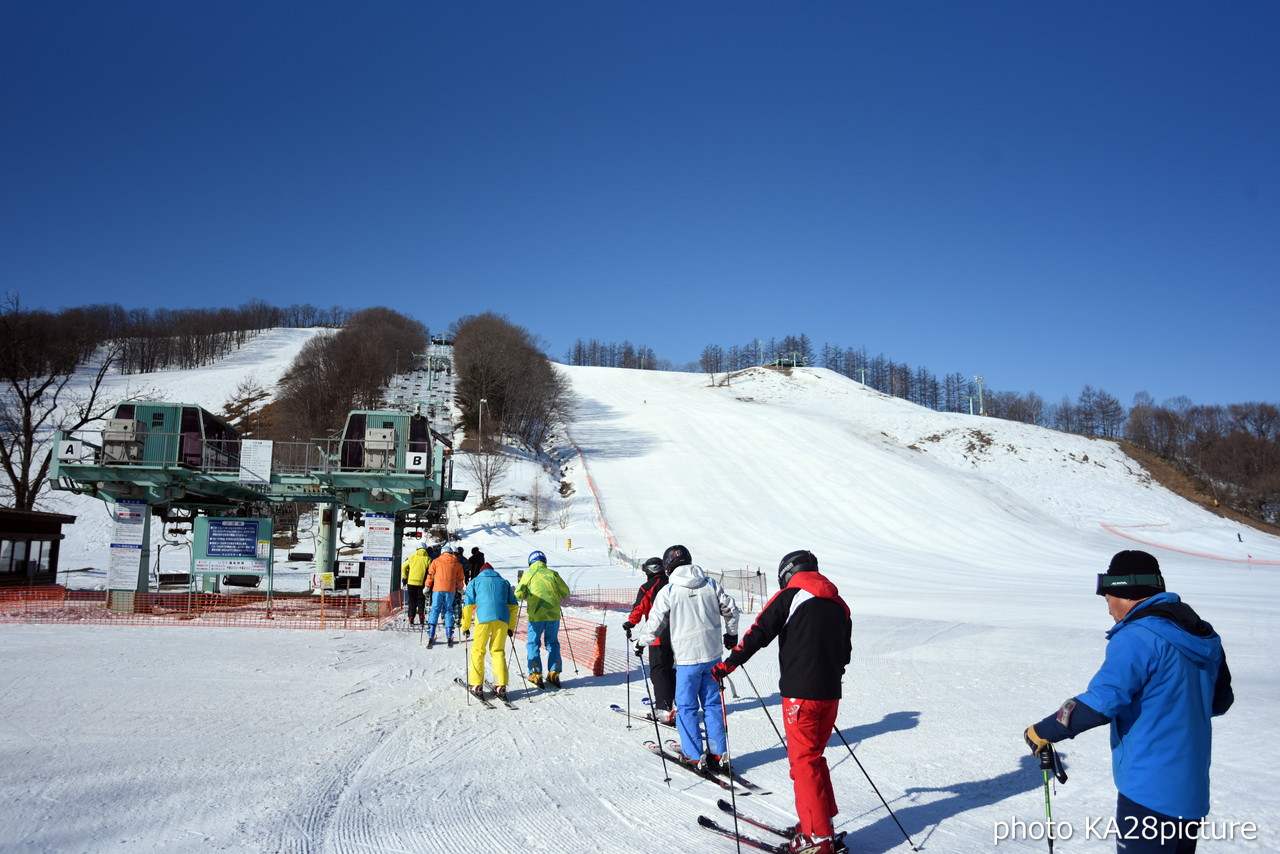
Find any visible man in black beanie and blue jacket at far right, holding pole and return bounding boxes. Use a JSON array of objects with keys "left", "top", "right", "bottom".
[{"left": 1023, "top": 551, "right": 1235, "bottom": 854}]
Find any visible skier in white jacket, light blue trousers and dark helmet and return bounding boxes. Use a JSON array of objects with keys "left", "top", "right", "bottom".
[{"left": 636, "top": 545, "right": 737, "bottom": 773}]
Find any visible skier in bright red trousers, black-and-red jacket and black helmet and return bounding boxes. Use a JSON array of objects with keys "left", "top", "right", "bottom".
[{"left": 712, "top": 551, "right": 854, "bottom": 854}]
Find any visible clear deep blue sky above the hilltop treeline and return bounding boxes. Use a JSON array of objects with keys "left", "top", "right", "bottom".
[{"left": 0, "top": 0, "right": 1280, "bottom": 405}]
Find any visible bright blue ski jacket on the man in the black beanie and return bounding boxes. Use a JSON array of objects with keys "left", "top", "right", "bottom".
[{"left": 1076, "top": 593, "right": 1234, "bottom": 819}]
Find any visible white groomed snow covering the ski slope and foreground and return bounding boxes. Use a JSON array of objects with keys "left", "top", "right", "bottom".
[{"left": 0, "top": 330, "right": 1280, "bottom": 854}]
